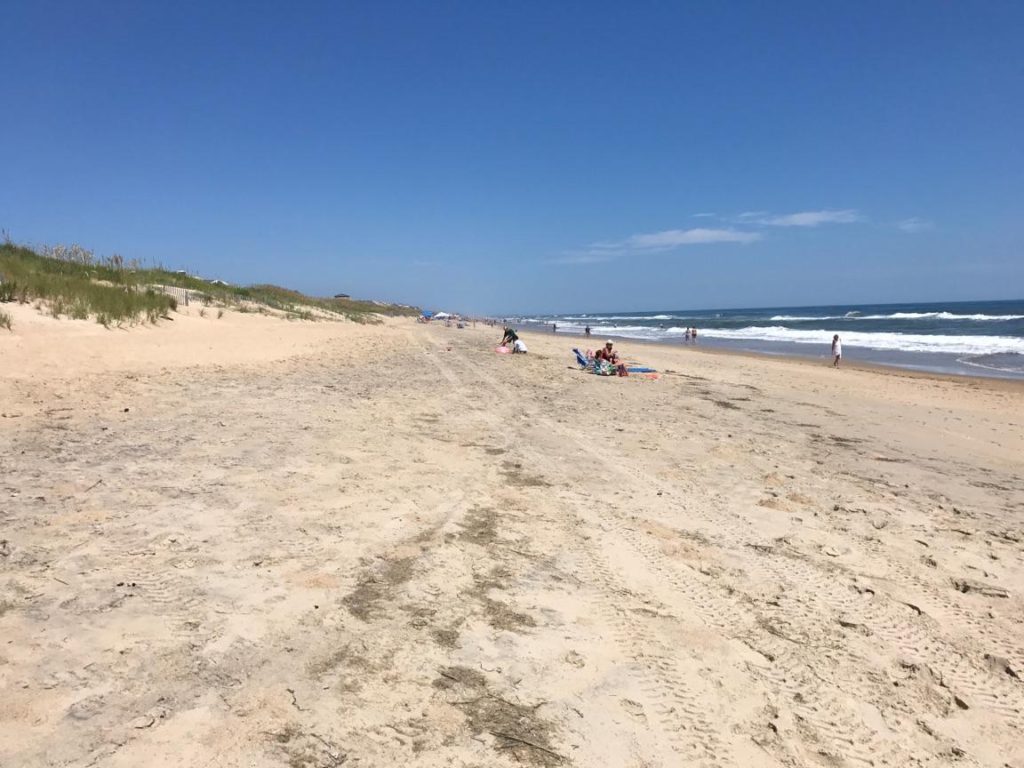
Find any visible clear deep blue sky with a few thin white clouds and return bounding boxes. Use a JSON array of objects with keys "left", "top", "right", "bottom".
[{"left": 0, "top": 0, "right": 1024, "bottom": 313}]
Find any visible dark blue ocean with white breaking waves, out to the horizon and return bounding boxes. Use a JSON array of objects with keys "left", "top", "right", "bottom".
[{"left": 510, "top": 300, "right": 1024, "bottom": 379}]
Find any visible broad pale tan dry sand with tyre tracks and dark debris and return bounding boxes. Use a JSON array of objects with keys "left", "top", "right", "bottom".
[{"left": 0, "top": 312, "right": 1024, "bottom": 768}]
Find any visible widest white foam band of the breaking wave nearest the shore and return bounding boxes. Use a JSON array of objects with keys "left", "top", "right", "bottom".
[{"left": 701, "top": 326, "right": 1024, "bottom": 354}]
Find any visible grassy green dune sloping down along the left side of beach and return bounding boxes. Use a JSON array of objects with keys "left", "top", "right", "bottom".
[{"left": 0, "top": 242, "right": 419, "bottom": 330}]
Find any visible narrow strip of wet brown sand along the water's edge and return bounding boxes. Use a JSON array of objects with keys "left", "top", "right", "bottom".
[{"left": 512, "top": 325, "right": 1024, "bottom": 392}]
